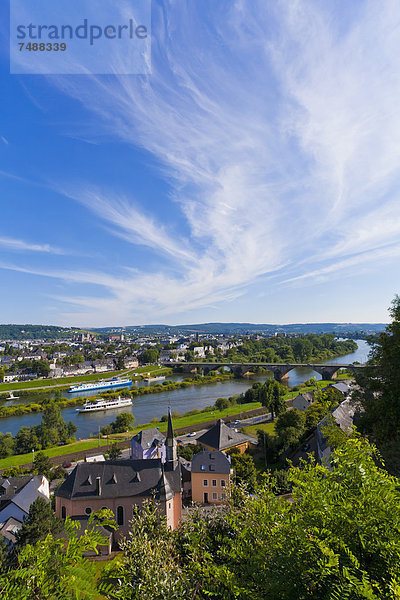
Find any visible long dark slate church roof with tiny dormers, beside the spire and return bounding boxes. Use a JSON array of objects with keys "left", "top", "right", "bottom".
[{"left": 56, "top": 458, "right": 181, "bottom": 500}]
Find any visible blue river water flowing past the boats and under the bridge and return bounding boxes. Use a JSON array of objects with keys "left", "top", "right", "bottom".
[{"left": 0, "top": 340, "right": 370, "bottom": 439}]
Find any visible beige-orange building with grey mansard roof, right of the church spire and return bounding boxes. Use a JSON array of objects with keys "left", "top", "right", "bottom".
[{"left": 192, "top": 450, "right": 232, "bottom": 504}]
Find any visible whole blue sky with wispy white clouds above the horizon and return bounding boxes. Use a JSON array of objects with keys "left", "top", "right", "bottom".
[{"left": 0, "top": 0, "right": 400, "bottom": 326}]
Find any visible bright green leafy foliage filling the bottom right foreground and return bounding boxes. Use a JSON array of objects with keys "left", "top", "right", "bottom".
[{"left": 101, "top": 438, "right": 400, "bottom": 600}]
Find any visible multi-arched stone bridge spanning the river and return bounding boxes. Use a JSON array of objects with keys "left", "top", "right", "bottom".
[{"left": 167, "top": 362, "right": 366, "bottom": 381}]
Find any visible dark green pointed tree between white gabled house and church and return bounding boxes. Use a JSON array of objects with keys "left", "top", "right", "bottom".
[{"left": 15, "top": 496, "right": 63, "bottom": 552}]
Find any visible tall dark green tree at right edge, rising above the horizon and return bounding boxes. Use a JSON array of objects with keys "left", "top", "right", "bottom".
[{"left": 354, "top": 296, "right": 400, "bottom": 476}]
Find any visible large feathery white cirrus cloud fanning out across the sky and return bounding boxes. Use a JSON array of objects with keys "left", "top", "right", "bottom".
[{"left": 5, "top": 0, "right": 400, "bottom": 322}]
